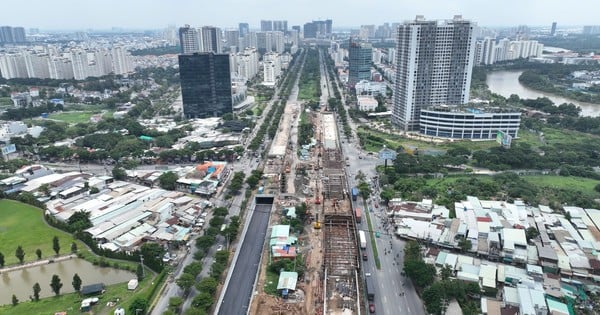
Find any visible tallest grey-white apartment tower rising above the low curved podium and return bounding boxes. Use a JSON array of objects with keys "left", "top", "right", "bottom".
[{"left": 392, "top": 16, "right": 475, "bottom": 131}]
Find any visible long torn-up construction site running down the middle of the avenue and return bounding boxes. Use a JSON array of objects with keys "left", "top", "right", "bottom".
[{"left": 250, "top": 49, "right": 361, "bottom": 315}]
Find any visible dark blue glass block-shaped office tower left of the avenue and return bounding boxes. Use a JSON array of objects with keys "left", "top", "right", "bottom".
[{"left": 179, "top": 52, "right": 233, "bottom": 118}]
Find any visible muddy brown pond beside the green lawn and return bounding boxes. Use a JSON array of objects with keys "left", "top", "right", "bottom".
[{"left": 0, "top": 258, "right": 136, "bottom": 305}]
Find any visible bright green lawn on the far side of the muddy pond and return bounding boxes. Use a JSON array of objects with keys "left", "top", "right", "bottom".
[{"left": 0, "top": 199, "right": 85, "bottom": 266}]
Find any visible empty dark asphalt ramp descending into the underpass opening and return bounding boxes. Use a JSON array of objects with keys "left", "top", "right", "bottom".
[{"left": 218, "top": 205, "right": 273, "bottom": 315}]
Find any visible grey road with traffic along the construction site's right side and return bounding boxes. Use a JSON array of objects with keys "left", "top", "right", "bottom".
[{"left": 321, "top": 47, "right": 425, "bottom": 315}]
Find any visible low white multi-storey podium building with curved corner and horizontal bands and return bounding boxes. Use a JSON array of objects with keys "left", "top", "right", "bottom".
[{"left": 419, "top": 105, "right": 521, "bottom": 140}]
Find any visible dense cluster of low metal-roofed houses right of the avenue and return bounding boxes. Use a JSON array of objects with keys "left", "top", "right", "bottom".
[{"left": 387, "top": 197, "right": 600, "bottom": 315}]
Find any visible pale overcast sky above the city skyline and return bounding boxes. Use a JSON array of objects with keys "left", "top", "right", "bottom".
[{"left": 0, "top": 0, "right": 600, "bottom": 30}]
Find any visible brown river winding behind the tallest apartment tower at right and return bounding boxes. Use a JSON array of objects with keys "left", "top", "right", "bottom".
[{"left": 486, "top": 70, "right": 600, "bottom": 117}]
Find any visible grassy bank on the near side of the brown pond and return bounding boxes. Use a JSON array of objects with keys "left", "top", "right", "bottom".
[{"left": 0, "top": 276, "right": 160, "bottom": 315}]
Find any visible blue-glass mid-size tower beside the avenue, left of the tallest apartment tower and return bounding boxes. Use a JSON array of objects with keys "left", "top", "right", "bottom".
[{"left": 348, "top": 38, "right": 373, "bottom": 88}]
